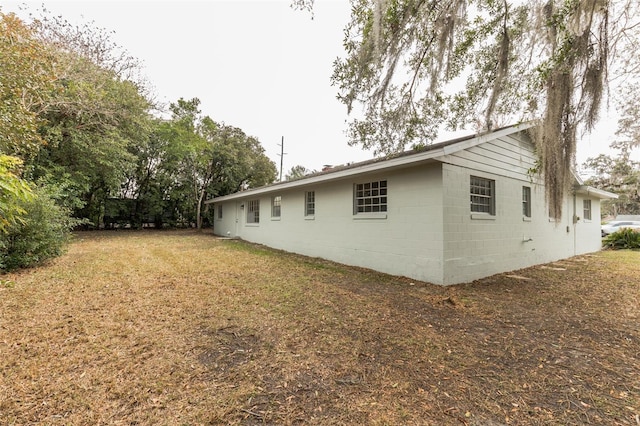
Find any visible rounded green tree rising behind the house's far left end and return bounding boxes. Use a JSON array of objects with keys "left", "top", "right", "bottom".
[{"left": 125, "top": 98, "right": 276, "bottom": 228}]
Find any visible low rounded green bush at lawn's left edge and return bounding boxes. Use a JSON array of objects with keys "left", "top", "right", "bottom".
[{"left": 0, "top": 188, "right": 75, "bottom": 272}]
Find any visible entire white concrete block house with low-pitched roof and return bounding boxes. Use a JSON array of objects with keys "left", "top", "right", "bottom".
[{"left": 207, "top": 125, "right": 615, "bottom": 285}]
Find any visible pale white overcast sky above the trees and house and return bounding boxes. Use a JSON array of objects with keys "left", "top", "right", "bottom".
[{"left": 2, "top": 0, "right": 616, "bottom": 174}]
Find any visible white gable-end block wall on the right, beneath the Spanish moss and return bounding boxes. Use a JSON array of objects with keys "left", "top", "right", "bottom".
[{"left": 443, "top": 133, "right": 601, "bottom": 284}]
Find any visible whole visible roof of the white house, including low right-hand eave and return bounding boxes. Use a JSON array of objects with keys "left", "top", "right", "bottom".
[{"left": 205, "top": 123, "right": 618, "bottom": 204}]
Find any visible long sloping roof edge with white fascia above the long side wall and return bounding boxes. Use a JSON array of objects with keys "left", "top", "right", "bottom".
[{"left": 205, "top": 123, "right": 534, "bottom": 204}]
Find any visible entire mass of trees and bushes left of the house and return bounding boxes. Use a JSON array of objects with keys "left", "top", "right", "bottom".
[{"left": 0, "top": 10, "right": 276, "bottom": 271}]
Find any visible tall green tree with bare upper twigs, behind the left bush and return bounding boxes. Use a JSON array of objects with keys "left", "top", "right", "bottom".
[{"left": 27, "top": 11, "right": 151, "bottom": 226}]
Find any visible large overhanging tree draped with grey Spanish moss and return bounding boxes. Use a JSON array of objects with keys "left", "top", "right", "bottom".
[{"left": 293, "top": 0, "right": 640, "bottom": 217}]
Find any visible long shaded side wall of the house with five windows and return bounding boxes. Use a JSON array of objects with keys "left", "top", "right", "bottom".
[{"left": 214, "top": 162, "right": 443, "bottom": 283}]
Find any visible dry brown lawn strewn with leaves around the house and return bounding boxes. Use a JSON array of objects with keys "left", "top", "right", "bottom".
[{"left": 0, "top": 232, "right": 640, "bottom": 425}]
